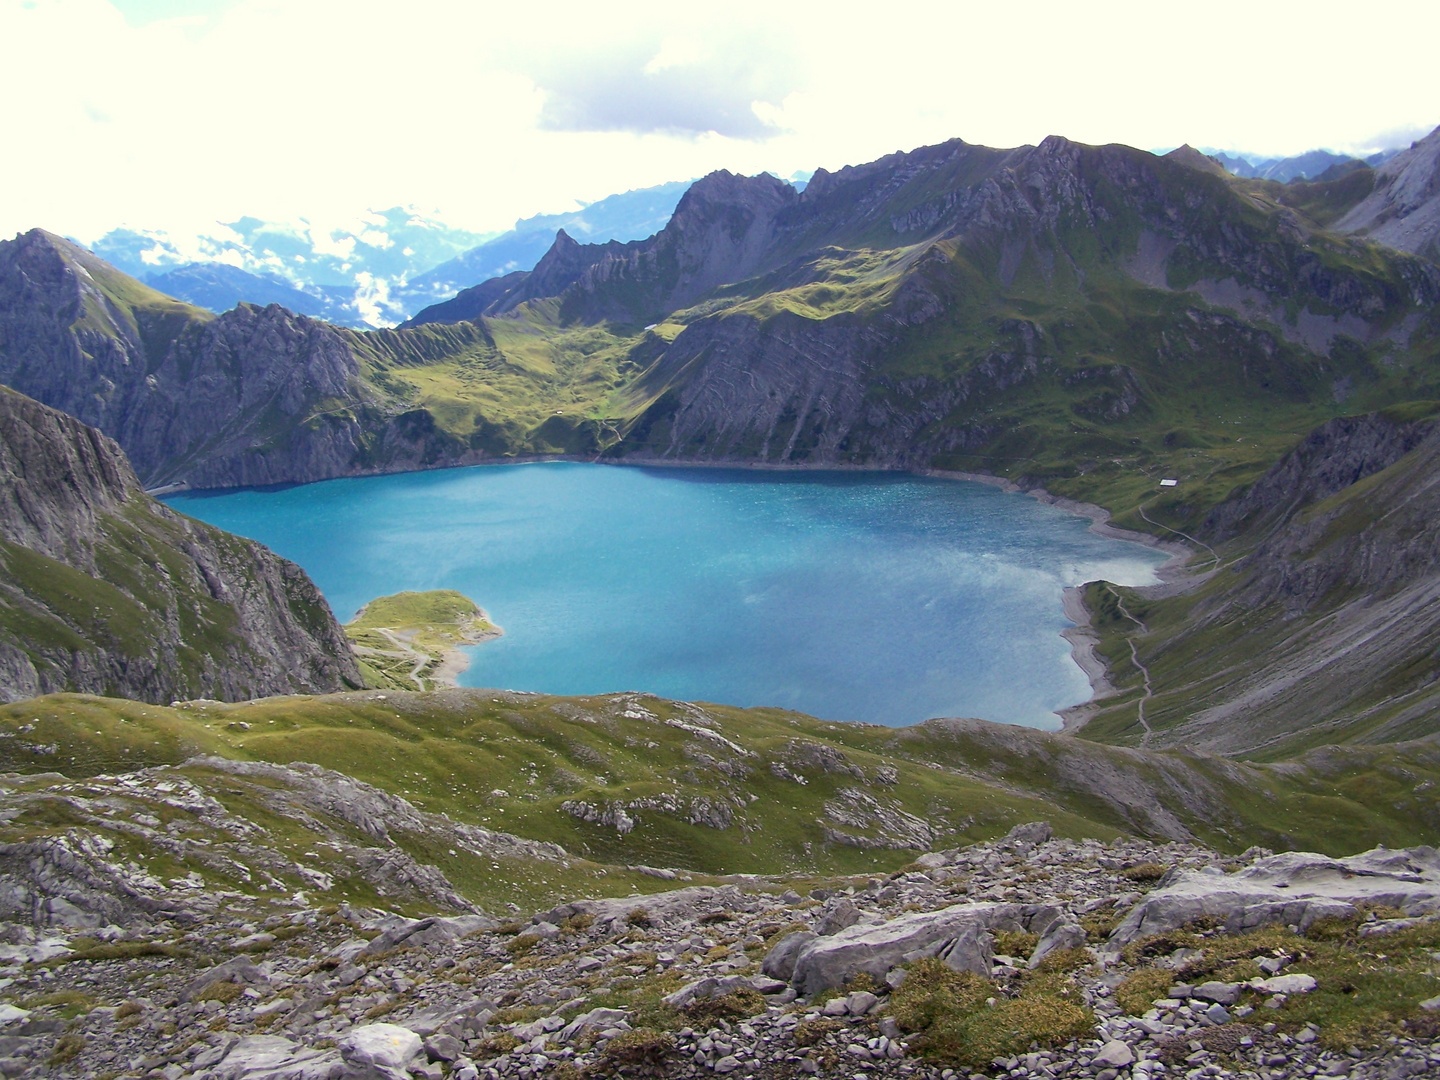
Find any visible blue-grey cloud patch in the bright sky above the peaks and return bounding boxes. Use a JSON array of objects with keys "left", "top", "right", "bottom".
[{"left": 521, "top": 27, "right": 802, "bottom": 140}]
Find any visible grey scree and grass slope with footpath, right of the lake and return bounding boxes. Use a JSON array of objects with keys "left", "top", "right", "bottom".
[{"left": 1083, "top": 403, "right": 1440, "bottom": 759}]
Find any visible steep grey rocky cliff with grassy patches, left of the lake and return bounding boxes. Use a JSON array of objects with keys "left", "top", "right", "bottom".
[{"left": 0, "top": 387, "right": 361, "bottom": 701}]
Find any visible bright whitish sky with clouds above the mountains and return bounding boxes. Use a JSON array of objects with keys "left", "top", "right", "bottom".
[{"left": 0, "top": 0, "right": 1440, "bottom": 239}]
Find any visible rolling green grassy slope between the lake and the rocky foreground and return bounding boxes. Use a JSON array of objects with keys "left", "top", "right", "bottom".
[{"left": 0, "top": 690, "right": 1440, "bottom": 898}]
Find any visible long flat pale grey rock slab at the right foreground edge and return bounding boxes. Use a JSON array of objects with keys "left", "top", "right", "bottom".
[{"left": 1106, "top": 847, "right": 1440, "bottom": 952}]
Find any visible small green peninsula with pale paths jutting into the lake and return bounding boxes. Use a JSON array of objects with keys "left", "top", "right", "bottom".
[{"left": 346, "top": 589, "right": 504, "bottom": 690}]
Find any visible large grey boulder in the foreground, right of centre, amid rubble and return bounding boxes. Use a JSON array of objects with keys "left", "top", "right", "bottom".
[{"left": 791, "top": 903, "right": 1057, "bottom": 996}]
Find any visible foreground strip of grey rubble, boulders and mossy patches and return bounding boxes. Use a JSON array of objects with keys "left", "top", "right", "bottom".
[{"left": 0, "top": 822, "right": 1440, "bottom": 1080}]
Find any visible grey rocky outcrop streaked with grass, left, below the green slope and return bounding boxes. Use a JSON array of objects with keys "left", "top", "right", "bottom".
[{"left": 0, "top": 757, "right": 567, "bottom": 933}]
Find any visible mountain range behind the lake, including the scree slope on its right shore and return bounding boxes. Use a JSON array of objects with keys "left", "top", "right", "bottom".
[{"left": 0, "top": 124, "right": 1440, "bottom": 817}]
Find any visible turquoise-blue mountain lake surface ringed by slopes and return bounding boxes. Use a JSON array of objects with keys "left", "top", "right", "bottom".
[{"left": 166, "top": 462, "right": 1165, "bottom": 729}]
